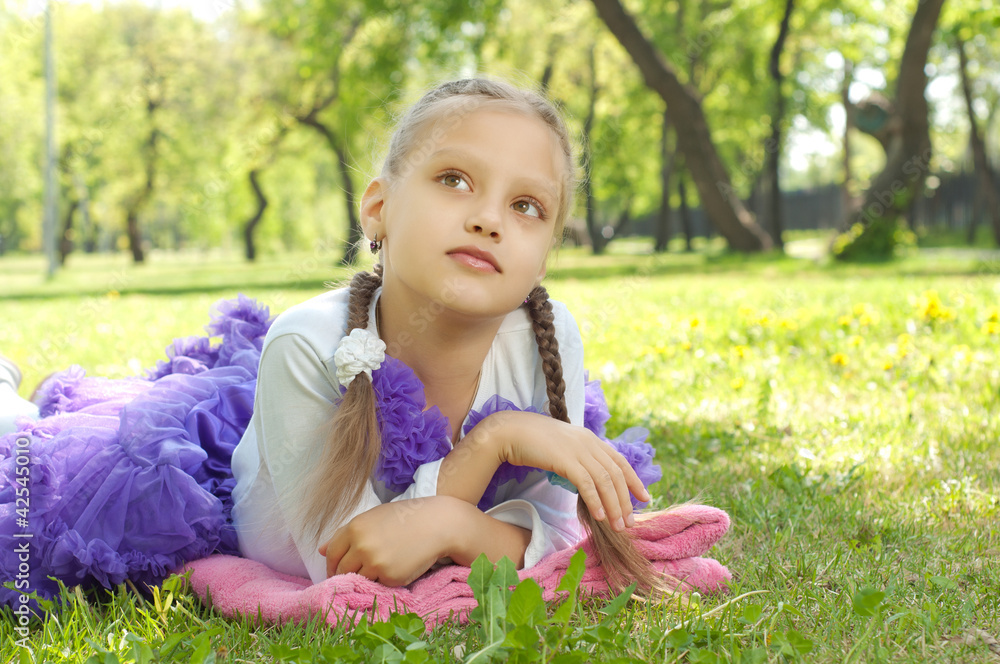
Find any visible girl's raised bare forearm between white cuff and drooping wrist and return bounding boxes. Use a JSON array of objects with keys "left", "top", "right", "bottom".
[{"left": 437, "top": 412, "right": 516, "bottom": 505}]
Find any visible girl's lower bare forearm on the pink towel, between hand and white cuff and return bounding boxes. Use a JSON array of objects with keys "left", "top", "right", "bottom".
[{"left": 448, "top": 501, "right": 531, "bottom": 569}]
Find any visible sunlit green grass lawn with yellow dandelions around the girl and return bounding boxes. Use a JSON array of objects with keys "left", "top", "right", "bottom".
[{"left": 0, "top": 243, "right": 1000, "bottom": 662}]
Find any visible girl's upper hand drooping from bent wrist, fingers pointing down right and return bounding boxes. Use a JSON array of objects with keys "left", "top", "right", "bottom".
[{"left": 484, "top": 411, "right": 650, "bottom": 531}]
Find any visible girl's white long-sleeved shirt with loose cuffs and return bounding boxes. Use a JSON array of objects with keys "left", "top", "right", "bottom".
[{"left": 233, "top": 289, "right": 584, "bottom": 583}]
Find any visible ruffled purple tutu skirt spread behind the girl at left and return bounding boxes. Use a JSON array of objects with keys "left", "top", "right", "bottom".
[{"left": 0, "top": 295, "right": 271, "bottom": 607}]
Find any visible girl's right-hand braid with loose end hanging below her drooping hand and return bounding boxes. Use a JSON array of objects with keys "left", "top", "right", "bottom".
[{"left": 526, "top": 286, "right": 680, "bottom": 594}]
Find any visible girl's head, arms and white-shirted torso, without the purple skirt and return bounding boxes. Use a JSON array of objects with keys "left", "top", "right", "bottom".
[{"left": 233, "top": 79, "right": 658, "bottom": 587}]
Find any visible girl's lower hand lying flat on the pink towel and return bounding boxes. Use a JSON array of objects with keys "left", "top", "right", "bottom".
[{"left": 319, "top": 497, "right": 454, "bottom": 586}]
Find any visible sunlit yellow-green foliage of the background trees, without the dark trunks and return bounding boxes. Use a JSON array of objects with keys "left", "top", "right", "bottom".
[{"left": 0, "top": 0, "right": 1000, "bottom": 260}]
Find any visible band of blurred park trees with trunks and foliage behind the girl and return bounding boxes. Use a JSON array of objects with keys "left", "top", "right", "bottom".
[{"left": 0, "top": 0, "right": 1000, "bottom": 263}]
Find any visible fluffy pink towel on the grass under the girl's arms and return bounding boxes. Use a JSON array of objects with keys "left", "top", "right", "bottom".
[{"left": 182, "top": 505, "right": 731, "bottom": 627}]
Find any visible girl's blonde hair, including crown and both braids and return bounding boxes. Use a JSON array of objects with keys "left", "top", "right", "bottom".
[{"left": 303, "top": 78, "right": 675, "bottom": 592}]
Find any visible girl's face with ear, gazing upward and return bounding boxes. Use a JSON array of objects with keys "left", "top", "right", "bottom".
[{"left": 361, "top": 107, "right": 564, "bottom": 317}]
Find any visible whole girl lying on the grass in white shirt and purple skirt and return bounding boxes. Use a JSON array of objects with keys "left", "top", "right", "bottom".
[{"left": 0, "top": 80, "right": 665, "bottom": 616}]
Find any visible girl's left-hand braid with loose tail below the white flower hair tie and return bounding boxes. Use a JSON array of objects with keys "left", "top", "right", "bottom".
[{"left": 302, "top": 265, "right": 382, "bottom": 542}]
